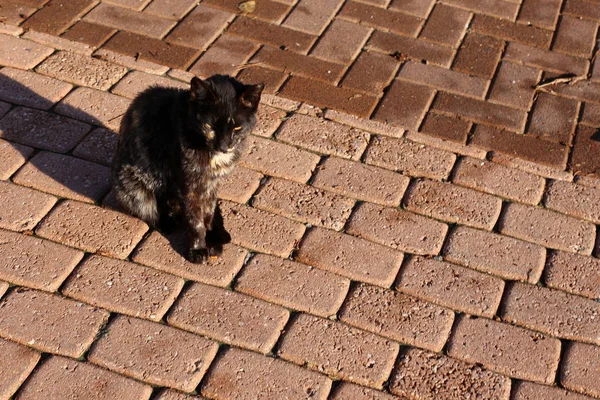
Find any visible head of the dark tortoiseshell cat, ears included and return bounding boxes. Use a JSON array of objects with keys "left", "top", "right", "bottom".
[{"left": 190, "top": 75, "right": 264, "bottom": 153}]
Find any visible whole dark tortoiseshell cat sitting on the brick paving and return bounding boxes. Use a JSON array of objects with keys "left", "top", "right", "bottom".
[{"left": 112, "top": 75, "right": 263, "bottom": 262}]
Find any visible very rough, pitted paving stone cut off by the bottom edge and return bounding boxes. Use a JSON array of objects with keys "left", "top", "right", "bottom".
[{"left": 390, "top": 348, "right": 511, "bottom": 400}]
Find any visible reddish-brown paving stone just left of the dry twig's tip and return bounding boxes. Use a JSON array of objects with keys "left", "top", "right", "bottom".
[{"left": 489, "top": 62, "right": 540, "bottom": 110}]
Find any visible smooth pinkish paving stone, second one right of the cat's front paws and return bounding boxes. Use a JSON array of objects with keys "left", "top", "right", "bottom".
[{"left": 296, "top": 228, "right": 403, "bottom": 287}]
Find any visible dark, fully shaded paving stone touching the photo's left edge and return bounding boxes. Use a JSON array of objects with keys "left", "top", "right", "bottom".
[{"left": 0, "top": 107, "right": 90, "bottom": 153}]
